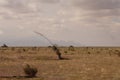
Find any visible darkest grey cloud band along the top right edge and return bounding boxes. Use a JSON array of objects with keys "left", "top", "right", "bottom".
[{"left": 73, "top": 0, "right": 120, "bottom": 10}]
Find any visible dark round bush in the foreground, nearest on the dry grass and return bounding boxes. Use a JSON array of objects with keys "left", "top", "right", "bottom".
[{"left": 24, "top": 64, "right": 38, "bottom": 77}]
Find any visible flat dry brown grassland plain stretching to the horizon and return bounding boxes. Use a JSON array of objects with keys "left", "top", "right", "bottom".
[{"left": 0, "top": 47, "right": 120, "bottom": 80}]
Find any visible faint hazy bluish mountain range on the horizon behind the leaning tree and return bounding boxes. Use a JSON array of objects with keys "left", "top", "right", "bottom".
[{"left": 0, "top": 38, "right": 83, "bottom": 46}]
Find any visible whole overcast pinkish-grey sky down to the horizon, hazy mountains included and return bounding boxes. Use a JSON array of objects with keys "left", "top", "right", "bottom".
[{"left": 0, "top": 0, "right": 120, "bottom": 46}]
